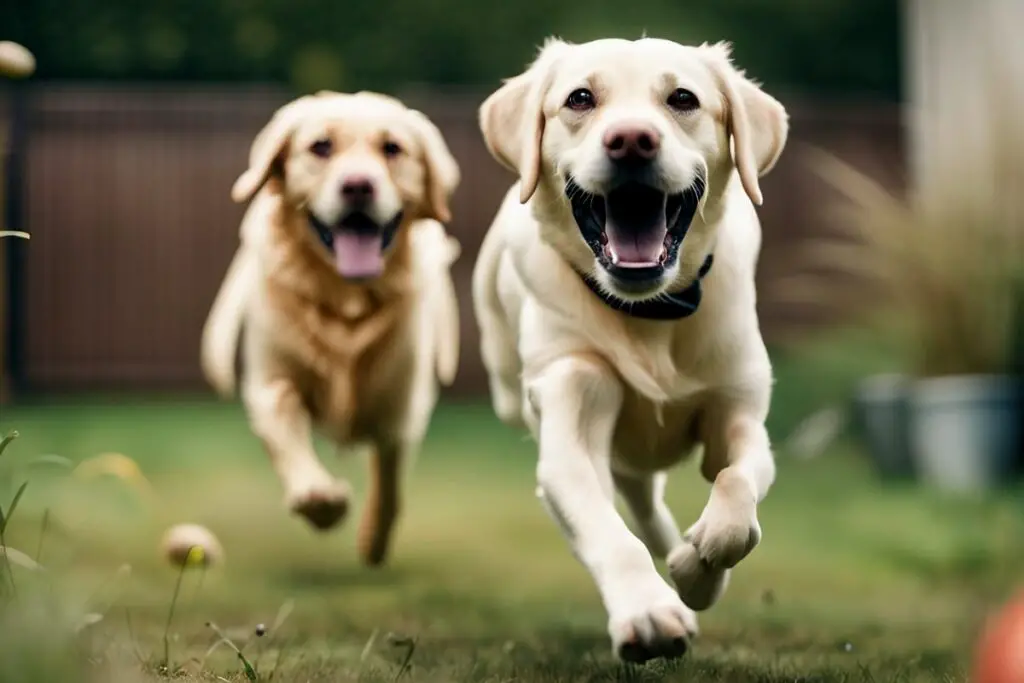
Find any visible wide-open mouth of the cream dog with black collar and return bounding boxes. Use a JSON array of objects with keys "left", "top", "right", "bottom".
[{"left": 565, "top": 177, "right": 705, "bottom": 281}]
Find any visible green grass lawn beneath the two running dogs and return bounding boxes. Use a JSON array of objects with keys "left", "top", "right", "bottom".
[{"left": 0, "top": 400, "right": 1024, "bottom": 683}]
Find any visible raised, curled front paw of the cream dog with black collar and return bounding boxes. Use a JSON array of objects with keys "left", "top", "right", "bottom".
[{"left": 669, "top": 473, "right": 761, "bottom": 610}]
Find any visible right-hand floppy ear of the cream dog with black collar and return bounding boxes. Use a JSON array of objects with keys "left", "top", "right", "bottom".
[{"left": 702, "top": 43, "right": 790, "bottom": 206}]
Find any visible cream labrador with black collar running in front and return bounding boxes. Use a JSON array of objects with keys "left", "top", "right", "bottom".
[{"left": 473, "top": 39, "right": 788, "bottom": 661}]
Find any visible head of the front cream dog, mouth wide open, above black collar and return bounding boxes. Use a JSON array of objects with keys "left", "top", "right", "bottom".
[{"left": 479, "top": 38, "right": 788, "bottom": 301}]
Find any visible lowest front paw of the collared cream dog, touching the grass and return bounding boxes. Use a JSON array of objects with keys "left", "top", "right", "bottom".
[{"left": 608, "top": 582, "right": 697, "bottom": 664}]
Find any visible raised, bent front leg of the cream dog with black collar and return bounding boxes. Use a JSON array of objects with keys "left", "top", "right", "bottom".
[{"left": 669, "top": 401, "right": 775, "bottom": 610}]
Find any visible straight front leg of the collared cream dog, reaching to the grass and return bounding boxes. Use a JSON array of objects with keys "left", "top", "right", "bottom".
[{"left": 526, "top": 356, "right": 696, "bottom": 661}]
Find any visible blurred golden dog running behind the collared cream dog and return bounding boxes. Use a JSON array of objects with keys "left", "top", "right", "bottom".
[{"left": 202, "top": 92, "right": 459, "bottom": 564}]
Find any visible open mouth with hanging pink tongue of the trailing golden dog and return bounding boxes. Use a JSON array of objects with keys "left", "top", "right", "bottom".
[{"left": 309, "top": 211, "right": 402, "bottom": 280}]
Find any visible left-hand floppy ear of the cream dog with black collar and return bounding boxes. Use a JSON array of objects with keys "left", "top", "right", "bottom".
[{"left": 479, "top": 38, "right": 570, "bottom": 204}]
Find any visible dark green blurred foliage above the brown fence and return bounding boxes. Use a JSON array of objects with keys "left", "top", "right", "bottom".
[{"left": 0, "top": 0, "right": 900, "bottom": 99}]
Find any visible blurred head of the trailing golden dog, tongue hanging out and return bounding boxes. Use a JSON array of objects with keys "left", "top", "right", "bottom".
[{"left": 231, "top": 92, "right": 459, "bottom": 280}]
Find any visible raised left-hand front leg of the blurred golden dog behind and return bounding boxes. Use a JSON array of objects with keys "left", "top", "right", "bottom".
[{"left": 244, "top": 378, "right": 350, "bottom": 530}]
